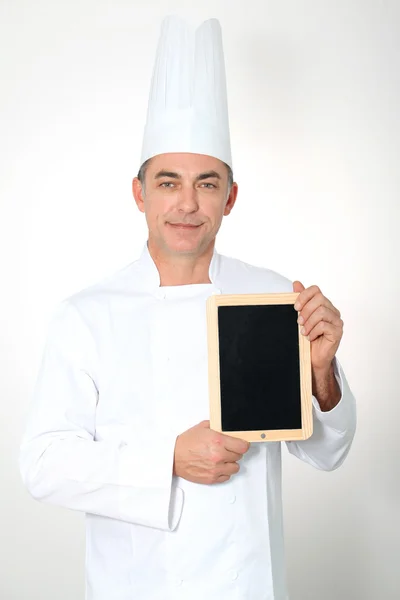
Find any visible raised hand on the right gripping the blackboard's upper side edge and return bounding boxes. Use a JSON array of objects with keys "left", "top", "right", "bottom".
[{"left": 293, "top": 281, "right": 343, "bottom": 373}]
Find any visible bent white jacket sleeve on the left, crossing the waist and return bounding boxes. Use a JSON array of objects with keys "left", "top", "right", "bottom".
[{"left": 20, "top": 300, "right": 183, "bottom": 531}]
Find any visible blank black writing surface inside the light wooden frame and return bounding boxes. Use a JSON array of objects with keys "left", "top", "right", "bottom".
[{"left": 218, "top": 304, "right": 302, "bottom": 432}]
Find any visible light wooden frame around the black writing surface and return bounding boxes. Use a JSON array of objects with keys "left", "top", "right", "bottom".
[{"left": 207, "top": 293, "right": 313, "bottom": 442}]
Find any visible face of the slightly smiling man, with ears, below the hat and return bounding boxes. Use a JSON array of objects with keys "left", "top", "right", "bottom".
[{"left": 133, "top": 153, "right": 237, "bottom": 255}]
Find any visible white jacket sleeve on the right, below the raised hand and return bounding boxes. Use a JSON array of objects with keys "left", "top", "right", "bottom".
[{"left": 286, "top": 357, "right": 356, "bottom": 471}]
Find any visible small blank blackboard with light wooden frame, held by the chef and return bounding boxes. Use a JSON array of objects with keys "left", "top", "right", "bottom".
[{"left": 207, "top": 293, "right": 312, "bottom": 442}]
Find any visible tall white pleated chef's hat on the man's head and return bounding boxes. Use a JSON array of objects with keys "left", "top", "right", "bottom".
[{"left": 141, "top": 16, "right": 232, "bottom": 167}]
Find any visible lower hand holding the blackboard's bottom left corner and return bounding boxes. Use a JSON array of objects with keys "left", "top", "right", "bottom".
[{"left": 174, "top": 421, "right": 250, "bottom": 484}]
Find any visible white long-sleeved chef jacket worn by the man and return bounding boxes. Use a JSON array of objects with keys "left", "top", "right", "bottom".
[{"left": 20, "top": 244, "right": 356, "bottom": 600}]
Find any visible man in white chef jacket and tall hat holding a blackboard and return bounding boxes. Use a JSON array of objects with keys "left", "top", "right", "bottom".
[{"left": 20, "top": 12, "right": 356, "bottom": 600}]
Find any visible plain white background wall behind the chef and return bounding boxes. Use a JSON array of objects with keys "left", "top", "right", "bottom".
[{"left": 0, "top": 0, "right": 400, "bottom": 600}]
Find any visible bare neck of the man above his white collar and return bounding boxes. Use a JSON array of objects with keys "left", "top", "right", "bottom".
[{"left": 148, "top": 241, "right": 214, "bottom": 286}]
